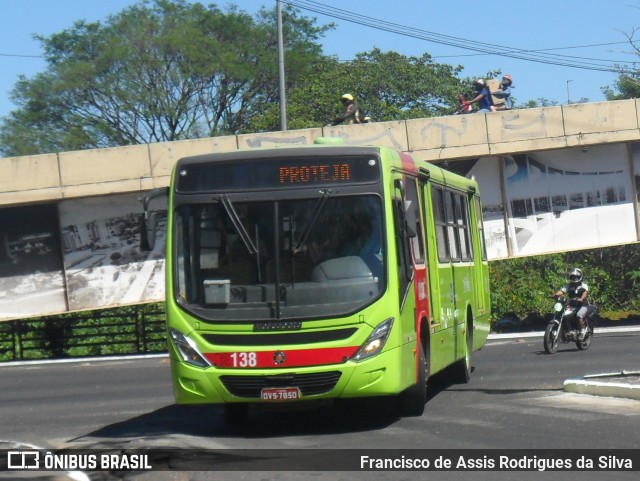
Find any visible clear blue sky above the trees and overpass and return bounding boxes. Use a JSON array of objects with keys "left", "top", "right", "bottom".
[{"left": 0, "top": 0, "right": 640, "bottom": 117}]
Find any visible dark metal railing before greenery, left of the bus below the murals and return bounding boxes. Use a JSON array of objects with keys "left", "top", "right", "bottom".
[{"left": 0, "top": 304, "right": 167, "bottom": 361}]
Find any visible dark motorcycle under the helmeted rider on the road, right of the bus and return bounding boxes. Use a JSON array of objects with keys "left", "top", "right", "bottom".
[{"left": 544, "top": 296, "right": 597, "bottom": 354}]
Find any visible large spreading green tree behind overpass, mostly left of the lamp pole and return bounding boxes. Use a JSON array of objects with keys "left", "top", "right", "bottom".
[{"left": 0, "top": 0, "right": 331, "bottom": 156}]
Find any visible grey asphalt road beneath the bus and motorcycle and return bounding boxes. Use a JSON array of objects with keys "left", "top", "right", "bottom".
[{"left": 0, "top": 333, "right": 640, "bottom": 481}]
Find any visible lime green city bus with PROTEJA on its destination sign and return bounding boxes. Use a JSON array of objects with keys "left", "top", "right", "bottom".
[{"left": 143, "top": 139, "right": 490, "bottom": 418}]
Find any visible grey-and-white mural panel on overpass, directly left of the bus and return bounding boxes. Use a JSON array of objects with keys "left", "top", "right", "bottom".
[{"left": 60, "top": 194, "right": 166, "bottom": 310}]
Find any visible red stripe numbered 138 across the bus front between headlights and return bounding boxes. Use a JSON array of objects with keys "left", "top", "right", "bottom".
[{"left": 204, "top": 346, "right": 360, "bottom": 369}]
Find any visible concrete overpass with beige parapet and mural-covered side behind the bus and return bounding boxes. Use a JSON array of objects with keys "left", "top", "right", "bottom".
[{"left": 0, "top": 100, "right": 640, "bottom": 319}]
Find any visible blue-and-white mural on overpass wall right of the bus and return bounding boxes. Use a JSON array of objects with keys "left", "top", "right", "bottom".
[{"left": 469, "top": 144, "right": 638, "bottom": 259}]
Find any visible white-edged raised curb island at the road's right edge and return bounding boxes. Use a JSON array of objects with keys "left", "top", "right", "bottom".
[{"left": 564, "top": 371, "right": 640, "bottom": 401}]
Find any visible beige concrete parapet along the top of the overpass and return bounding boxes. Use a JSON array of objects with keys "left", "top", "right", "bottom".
[{"left": 0, "top": 100, "right": 640, "bottom": 206}]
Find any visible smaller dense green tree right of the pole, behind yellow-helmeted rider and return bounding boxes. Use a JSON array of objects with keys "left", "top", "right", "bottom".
[{"left": 250, "top": 49, "right": 471, "bottom": 131}]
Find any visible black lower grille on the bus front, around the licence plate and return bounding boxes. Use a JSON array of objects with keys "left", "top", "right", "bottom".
[{"left": 220, "top": 371, "right": 341, "bottom": 397}]
